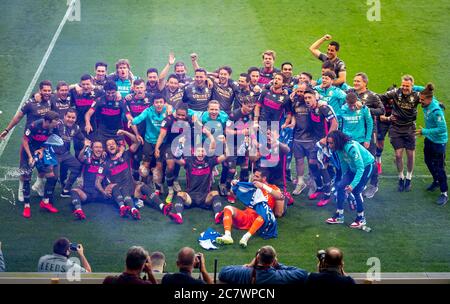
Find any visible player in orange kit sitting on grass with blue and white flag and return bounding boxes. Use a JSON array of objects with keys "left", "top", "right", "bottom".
[{"left": 216, "top": 169, "right": 284, "bottom": 247}]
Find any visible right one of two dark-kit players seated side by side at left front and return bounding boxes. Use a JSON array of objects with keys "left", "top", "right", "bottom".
[{"left": 95, "top": 130, "right": 141, "bottom": 220}]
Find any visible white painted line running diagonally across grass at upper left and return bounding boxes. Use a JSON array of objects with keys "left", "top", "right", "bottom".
[{"left": 0, "top": 0, "right": 77, "bottom": 157}]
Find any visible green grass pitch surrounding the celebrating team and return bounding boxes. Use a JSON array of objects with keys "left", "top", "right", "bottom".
[{"left": 0, "top": 0, "right": 450, "bottom": 272}]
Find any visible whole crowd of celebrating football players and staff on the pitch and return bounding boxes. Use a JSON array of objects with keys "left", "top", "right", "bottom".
[{"left": 0, "top": 35, "right": 448, "bottom": 245}]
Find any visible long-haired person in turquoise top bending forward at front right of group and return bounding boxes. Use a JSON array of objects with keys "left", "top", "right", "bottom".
[{"left": 326, "top": 130, "right": 375, "bottom": 229}]
